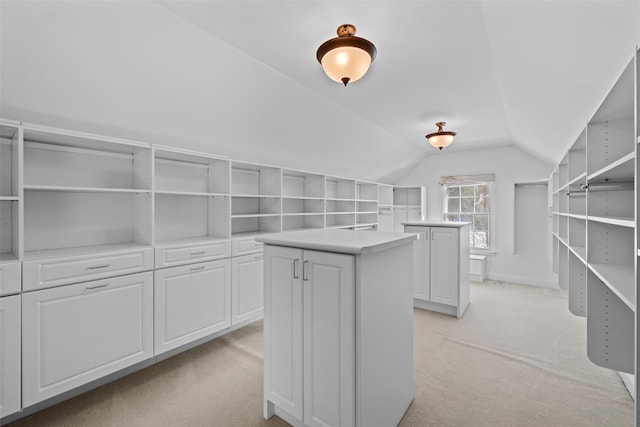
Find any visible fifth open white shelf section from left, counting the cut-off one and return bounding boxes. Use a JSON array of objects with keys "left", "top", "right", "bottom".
[{"left": 282, "top": 169, "right": 325, "bottom": 231}]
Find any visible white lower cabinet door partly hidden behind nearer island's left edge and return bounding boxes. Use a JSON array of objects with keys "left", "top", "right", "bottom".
[{"left": 231, "top": 253, "right": 264, "bottom": 325}]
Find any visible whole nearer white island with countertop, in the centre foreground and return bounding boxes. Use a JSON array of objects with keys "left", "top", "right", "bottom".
[{"left": 258, "top": 229, "right": 416, "bottom": 427}]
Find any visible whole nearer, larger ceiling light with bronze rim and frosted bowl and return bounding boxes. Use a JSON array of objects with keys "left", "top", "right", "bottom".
[{"left": 316, "top": 24, "right": 377, "bottom": 86}]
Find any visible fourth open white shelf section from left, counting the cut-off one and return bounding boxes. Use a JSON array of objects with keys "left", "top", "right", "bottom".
[{"left": 231, "top": 161, "right": 282, "bottom": 238}]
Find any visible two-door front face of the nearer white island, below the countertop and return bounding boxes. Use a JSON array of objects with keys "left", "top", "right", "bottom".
[{"left": 265, "top": 247, "right": 355, "bottom": 426}]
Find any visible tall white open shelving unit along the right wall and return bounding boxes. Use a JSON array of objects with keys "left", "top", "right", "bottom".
[{"left": 549, "top": 52, "right": 640, "bottom": 414}]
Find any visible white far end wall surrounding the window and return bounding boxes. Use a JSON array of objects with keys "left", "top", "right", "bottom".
[{"left": 397, "top": 142, "right": 557, "bottom": 287}]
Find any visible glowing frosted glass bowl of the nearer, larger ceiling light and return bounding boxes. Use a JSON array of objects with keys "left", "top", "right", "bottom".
[{"left": 321, "top": 46, "right": 371, "bottom": 83}]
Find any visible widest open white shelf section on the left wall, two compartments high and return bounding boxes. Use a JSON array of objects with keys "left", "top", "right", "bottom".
[{"left": 23, "top": 124, "right": 153, "bottom": 260}]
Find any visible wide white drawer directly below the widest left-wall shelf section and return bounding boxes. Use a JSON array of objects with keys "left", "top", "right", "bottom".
[{"left": 22, "top": 248, "right": 153, "bottom": 291}]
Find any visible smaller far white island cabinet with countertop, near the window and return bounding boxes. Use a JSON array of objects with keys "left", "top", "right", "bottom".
[{"left": 404, "top": 221, "right": 470, "bottom": 318}]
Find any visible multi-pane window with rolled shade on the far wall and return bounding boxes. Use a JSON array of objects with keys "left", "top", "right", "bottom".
[{"left": 441, "top": 175, "right": 494, "bottom": 251}]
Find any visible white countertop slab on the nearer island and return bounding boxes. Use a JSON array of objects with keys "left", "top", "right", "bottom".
[{"left": 256, "top": 229, "right": 416, "bottom": 255}]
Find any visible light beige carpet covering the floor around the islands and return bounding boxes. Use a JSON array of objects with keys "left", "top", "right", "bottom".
[{"left": 9, "top": 282, "right": 634, "bottom": 427}]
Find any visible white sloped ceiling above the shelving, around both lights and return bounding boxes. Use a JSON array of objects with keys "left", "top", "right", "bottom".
[{"left": 0, "top": 0, "right": 640, "bottom": 182}]
